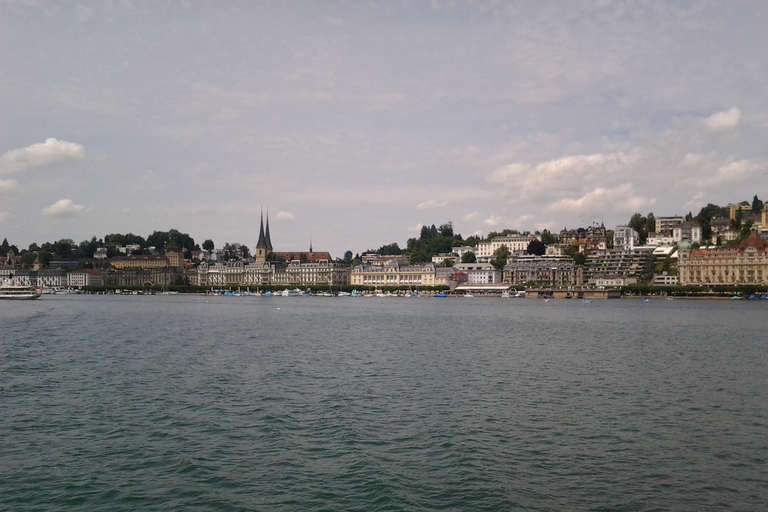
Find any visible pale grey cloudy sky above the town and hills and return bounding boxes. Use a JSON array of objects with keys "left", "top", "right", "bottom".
[{"left": 0, "top": 0, "right": 768, "bottom": 256}]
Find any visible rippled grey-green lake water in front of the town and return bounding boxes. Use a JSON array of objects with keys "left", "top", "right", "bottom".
[{"left": 0, "top": 295, "right": 768, "bottom": 511}]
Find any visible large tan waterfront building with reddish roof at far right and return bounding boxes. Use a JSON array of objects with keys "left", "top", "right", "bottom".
[{"left": 678, "top": 235, "right": 768, "bottom": 286}]
